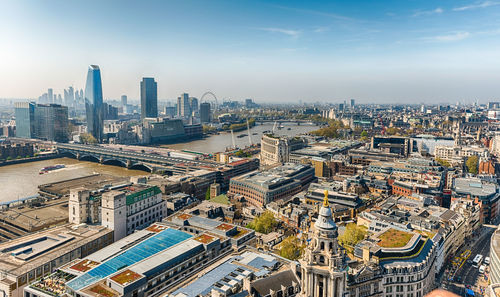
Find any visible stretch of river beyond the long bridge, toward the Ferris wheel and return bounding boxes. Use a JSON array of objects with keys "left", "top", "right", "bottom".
[{"left": 162, "top": 123, "right": 318, "bottom": 153}]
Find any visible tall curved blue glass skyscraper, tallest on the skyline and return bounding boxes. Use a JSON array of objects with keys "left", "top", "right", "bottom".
[{"left": 85, "top": 65, "right": 104, "bottom": 142}]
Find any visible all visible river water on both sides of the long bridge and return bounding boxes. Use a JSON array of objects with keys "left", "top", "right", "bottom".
[{"left": 0, "top": 123, "right": 317, "bottom": 202}]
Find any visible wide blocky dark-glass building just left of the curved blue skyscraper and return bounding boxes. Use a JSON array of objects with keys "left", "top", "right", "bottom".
[{"left": 35, "top": 104, "right": 69, "bottom": 142}]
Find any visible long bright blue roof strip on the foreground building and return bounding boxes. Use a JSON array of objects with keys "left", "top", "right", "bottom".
[{"left": 67, "top": 228, "right": 192, "bottom": 291}]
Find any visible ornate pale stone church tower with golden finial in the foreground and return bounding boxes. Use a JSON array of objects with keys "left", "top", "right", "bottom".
[{"left": 299, "top": 191, "right": 347, "bottom": 297}]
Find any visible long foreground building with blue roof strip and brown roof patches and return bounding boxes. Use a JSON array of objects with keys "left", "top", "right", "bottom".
[{"left": 24, "top": 213, "right": 254, "bottom": 297}]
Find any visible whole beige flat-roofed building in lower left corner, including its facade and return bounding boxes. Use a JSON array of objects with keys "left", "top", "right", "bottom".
[{"left": 0, "top": 224, "right": 113, "bottom": 297}]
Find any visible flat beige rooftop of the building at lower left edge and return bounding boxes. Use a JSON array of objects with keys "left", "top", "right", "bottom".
[{"left": 0, "top": 224, "right": 112, "bottom": 275}]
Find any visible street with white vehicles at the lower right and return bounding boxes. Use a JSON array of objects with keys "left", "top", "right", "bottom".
[{"left": 445, "top": 225, "right": 496, "bottom": 296}]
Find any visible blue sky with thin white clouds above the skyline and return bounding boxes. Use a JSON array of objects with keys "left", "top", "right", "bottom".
[{"left": 0, "top": 0, "right": 500, "bottom": 103}]
